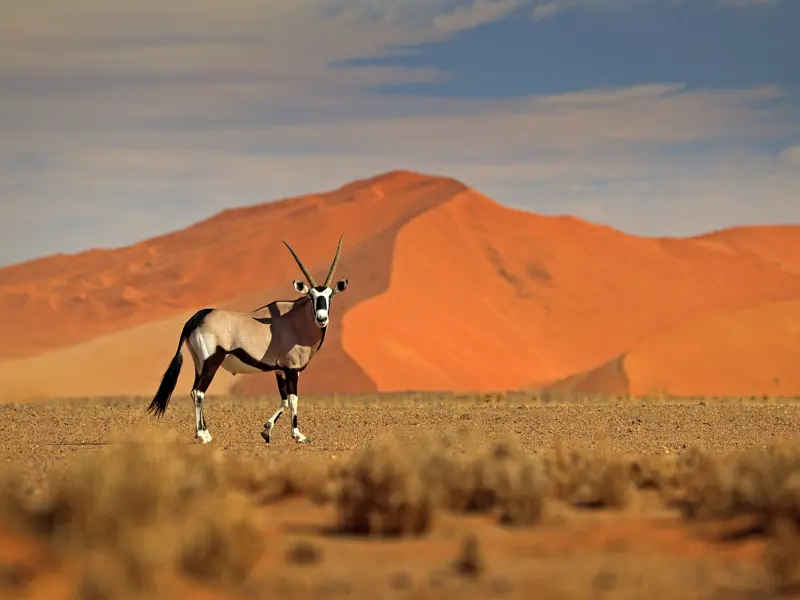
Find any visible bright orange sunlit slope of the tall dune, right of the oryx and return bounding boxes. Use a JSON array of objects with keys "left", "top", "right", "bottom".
[{"left": 343, "top": 190, "right": 800, "bottom": 390}]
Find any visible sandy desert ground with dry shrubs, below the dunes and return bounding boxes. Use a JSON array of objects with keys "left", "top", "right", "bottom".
[{"left": 0, "top": 393, "right": 800, "bottom": 600}]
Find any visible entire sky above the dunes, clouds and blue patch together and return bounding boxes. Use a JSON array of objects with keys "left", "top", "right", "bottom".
[{"left": 0, "top": 0, "right": 800, "bottom": 266}]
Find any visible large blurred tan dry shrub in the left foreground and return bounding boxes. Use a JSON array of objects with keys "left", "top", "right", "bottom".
[{"left": 0, "top": 434, "right": 262, "bottom": 597}]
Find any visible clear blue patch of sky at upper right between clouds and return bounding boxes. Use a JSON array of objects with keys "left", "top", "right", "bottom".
[{"left": 358, "top": 0, "right": 800, "bottom": 97}]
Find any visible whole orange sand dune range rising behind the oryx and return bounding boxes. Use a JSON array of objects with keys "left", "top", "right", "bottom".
[{"left": 0, "top": 171, "right": 800, "bottom": 399}]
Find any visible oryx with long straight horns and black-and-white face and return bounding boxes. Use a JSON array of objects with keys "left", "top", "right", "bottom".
[{"left": 147, "top": 234, "right": 347, "bottom": 444}]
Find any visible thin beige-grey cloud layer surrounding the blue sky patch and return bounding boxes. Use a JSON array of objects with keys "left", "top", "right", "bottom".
[{"left": 0, "top": 0, "right": 800, "bottom": 264}]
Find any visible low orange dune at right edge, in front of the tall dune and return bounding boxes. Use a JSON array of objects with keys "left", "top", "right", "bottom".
[{"left": 548, "top": 301, "right": 800, "bottom": 396}]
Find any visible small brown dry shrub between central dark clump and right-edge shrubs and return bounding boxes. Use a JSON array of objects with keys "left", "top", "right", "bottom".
[{"left": 543, "top": 443, "right": 631, "bottom": 508}]
